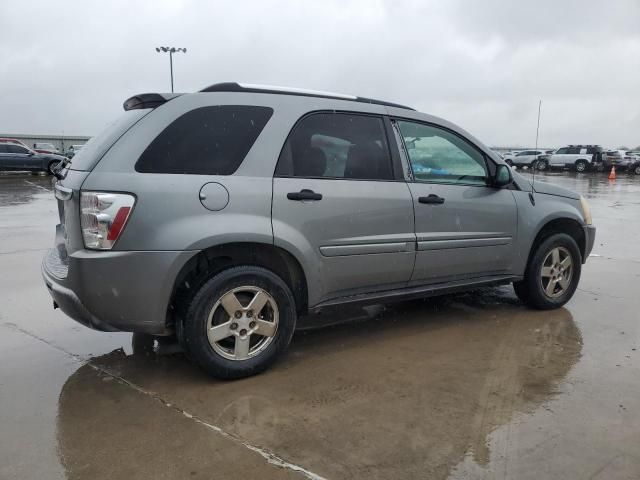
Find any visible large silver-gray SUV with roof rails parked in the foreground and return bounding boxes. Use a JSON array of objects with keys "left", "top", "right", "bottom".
[{"left": 42, "top": 83, "right": 595, "bottom": 378}]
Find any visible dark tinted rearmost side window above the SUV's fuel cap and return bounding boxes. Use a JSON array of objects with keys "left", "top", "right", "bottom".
[{"left": 136, "top": 105, "right": 273, "bottom": 175}]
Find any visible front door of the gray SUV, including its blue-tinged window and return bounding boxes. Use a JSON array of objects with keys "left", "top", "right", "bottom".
[{"left": 396, "top": 120, "right": 517, "bottom": 284}]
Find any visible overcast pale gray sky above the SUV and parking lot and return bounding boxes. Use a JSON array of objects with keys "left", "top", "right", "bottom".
[{"left": 0, "top": 0, "right": 640, "bottom": 147}]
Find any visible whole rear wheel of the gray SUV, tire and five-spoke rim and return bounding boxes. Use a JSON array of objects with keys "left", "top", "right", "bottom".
[{"left": 180, "top": 266, "right": 296, "bottom": 379}]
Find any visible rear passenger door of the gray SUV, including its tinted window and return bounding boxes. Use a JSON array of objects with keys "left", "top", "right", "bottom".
[{"left": 272, "top": 112, "right": 415, "bottom": 306}]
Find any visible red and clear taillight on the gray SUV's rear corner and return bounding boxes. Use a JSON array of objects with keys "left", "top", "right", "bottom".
[{"left": 80, "top": 192, "right": 136, "bottom": 250}]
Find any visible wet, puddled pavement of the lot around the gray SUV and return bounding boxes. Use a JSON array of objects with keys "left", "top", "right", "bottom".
[{"left": 0, "top": 173, "right": 640, "bottom": 479}]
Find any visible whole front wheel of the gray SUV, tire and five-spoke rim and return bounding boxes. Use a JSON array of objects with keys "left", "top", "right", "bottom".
[{"left": 513, "top": 233, "right": 582, "bottom": 310}]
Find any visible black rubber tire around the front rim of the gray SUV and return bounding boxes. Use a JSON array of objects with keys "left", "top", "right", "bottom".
[{"left": 513, "top": 233, "right": 582, "bottom": 310}]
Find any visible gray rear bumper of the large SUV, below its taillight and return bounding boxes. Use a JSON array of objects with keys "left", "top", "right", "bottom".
[{"left": 42, "top": 250, "right": 196, "bottom": 335}]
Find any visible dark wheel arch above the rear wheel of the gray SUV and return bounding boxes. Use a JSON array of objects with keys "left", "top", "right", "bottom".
[{"left": 165, "top": 242, "right": 308, "bottom": 327}]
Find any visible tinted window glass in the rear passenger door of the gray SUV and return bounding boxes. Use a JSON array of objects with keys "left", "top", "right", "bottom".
[{"left": 276, "top": 113, "right": 393, "bottom": 180}]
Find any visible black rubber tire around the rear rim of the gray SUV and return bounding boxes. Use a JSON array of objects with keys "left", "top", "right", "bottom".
[{"left": 179, "top": 266, "right": 297, "bottom": 379}]
